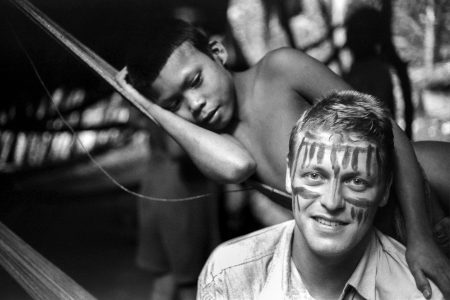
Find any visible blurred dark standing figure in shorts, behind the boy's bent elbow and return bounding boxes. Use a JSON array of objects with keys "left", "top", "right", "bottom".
[{"left": 137, "top": 125, "right": 219, "bottom": 299}]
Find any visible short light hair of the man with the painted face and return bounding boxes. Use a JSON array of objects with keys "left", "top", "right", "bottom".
[{"left": 288, "top": 91, "right": 394, "bottom": 182}]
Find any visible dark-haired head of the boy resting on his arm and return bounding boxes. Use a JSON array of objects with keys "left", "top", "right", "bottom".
[{"left": 127, "top": 19, "right": 235, "bottom": 130}]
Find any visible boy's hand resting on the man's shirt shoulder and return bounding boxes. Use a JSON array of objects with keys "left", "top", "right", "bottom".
[{"left": 406, "top": 240, "right": 450, "bottom": 299}]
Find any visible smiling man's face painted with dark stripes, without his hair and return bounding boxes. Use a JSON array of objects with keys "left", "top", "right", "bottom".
[{"left": 287, "top": 131, "right": 386, "bottom": 256}]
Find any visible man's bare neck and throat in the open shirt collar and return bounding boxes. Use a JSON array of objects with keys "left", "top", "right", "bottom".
[{"left": 292, "top": 226, "right": 369, "bottom": 299}]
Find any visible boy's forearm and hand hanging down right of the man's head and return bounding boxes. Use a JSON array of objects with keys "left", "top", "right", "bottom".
[{"left": 392, "top": 122, "right": 450, "bottom": 299}]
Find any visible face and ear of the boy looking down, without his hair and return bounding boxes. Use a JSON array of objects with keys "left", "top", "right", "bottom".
[{"left": 152, "top": 42, "right": 235, "bottom": 131}]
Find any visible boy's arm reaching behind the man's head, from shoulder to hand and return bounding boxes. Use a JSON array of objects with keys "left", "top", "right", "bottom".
[{"left": 271, "top": 49, "right": 450, "bottom": 298}]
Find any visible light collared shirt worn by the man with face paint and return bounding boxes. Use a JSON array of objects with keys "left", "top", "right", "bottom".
[{"left": 197, "top": 220, "right": 443, "bottom": 300}]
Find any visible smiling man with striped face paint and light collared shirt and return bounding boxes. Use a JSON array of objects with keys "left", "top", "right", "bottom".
[{"left": 197, "top": 91, "right": 443, "bottom": 299}]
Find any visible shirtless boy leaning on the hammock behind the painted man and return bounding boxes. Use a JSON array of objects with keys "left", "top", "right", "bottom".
[{"left": 118, "top": 21, "right": 450, "bottom": 297}]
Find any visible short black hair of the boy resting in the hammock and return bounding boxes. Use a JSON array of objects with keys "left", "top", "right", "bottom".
[{"left": 126, "top": 19, "right": 211, "bottom": 97}]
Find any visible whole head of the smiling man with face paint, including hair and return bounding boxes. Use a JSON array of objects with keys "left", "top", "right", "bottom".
[{"left": 286, "top": 91, "right": 394, "bottom": 256}]
